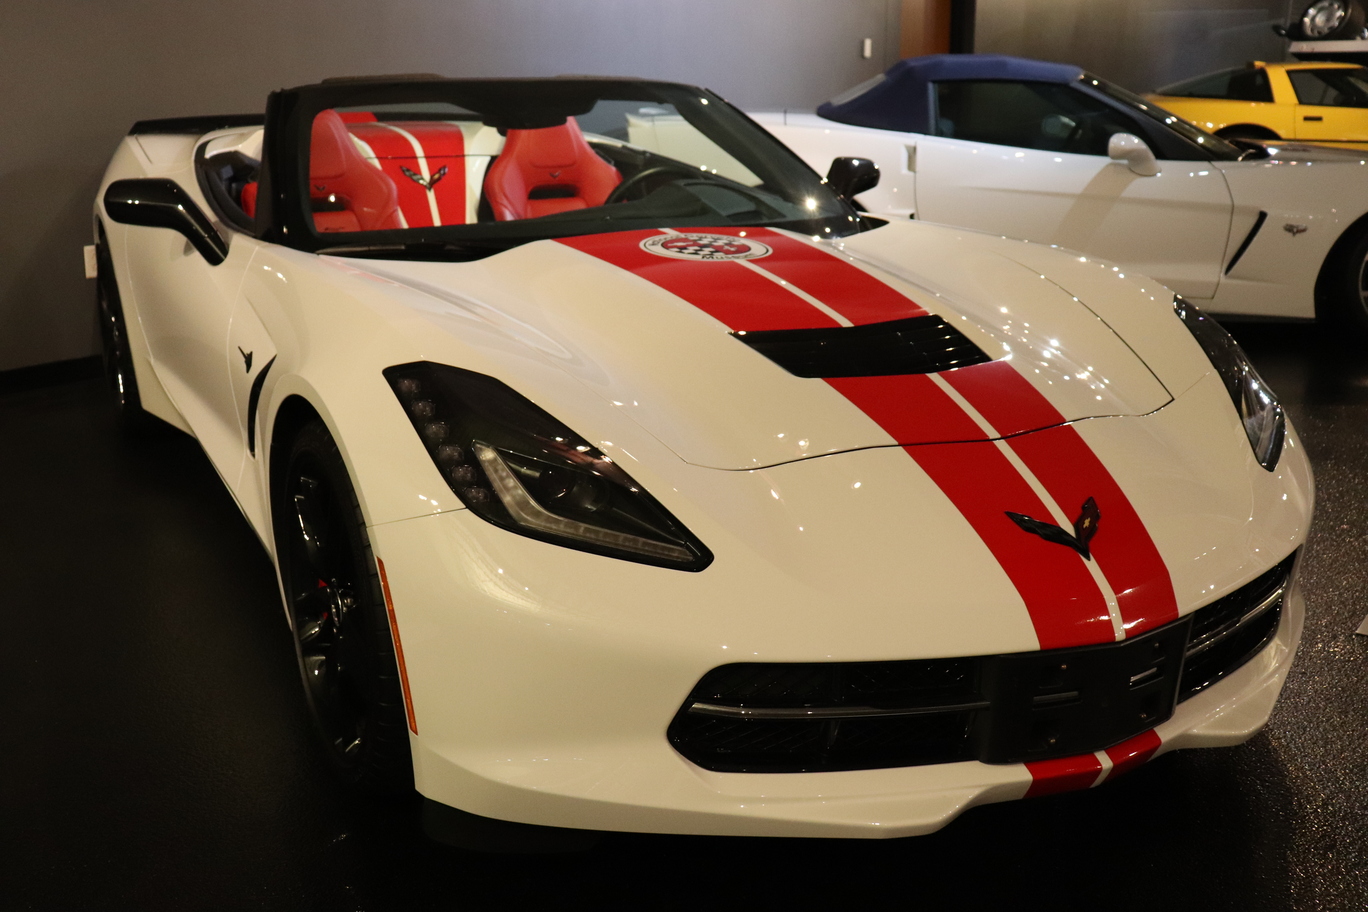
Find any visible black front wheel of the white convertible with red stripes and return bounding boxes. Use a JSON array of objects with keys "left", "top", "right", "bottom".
[{"left": 272, "top": 420, "right": 413, "bottom": 793}]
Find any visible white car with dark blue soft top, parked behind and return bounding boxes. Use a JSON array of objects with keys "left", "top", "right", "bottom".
[{"left": 752, "top": 55, "right": 1368, "bottom": 332}]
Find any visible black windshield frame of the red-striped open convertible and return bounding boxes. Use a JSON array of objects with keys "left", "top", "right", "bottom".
[{"left": 257, "top": 77, "right": 869, "bottom": 252}]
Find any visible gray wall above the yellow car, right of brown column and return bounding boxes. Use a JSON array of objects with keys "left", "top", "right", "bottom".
[{"left": 974, "top": 0, "right": 1308, "bottom": 92}]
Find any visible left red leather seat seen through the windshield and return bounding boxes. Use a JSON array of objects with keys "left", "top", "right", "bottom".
[{"left": 309, "top": 111, "right": 404, "bottom": 232}]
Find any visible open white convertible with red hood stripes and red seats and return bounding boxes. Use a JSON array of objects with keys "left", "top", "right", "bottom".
[{"left": 94, "top": 77, "right": 1312, "bottom": 845}]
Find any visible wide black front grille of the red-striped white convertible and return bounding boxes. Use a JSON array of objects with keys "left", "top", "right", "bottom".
[{"left": 668, "top": 554, "right": 1295, "bottom": 773}]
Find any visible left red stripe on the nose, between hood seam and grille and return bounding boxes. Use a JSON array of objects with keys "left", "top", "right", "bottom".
[{"left": 897, "top": 440, "right": 1115, "bottom": 649}]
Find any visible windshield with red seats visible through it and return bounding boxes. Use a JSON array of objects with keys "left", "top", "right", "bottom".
[{"left": 272, "top": 79, "right": 860, "bottom": 256}]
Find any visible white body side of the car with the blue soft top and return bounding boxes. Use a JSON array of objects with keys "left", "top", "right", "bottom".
[{"left": 751, "top": 111, "right": 1368, "bottom": 319}]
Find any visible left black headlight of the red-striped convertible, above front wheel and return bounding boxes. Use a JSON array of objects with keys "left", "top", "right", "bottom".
[{"left": 384, "top": 362, "right": 713, "bottom": 570}]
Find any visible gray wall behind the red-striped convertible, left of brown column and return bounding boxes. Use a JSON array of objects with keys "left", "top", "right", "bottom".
[{"left": 0, "top": 0, "right": 902, "bottom": 371}]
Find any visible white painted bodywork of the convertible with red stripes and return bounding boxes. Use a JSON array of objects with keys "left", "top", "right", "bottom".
[{"left": 96, "top": 96, "right": 1328, "bottom": 837}]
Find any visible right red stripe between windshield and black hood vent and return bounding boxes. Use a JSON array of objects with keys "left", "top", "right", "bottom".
[{"left": 718, "top": 228, "right": 926, "bottom": 325}]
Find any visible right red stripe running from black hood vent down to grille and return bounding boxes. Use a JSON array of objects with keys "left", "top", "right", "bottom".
[{"left": 941, "top": 361, "right": 1178, "bottom": 636}]
